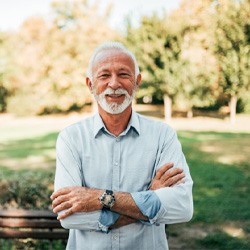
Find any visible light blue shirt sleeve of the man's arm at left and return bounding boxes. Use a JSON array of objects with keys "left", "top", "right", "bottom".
[{"left": 54, "top": 130, "right": 101, "bottom": 231}]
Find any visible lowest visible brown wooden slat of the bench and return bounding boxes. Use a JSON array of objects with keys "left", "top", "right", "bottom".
[{"left": 0, "top": 230, "right": 68, "bottom": 240}]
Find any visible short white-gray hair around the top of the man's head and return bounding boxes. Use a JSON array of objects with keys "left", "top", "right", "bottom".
[{"left": 87, "top": 42, "right": 140, "bottom": 79}]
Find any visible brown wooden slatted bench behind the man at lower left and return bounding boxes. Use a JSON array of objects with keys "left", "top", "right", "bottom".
[{"left": 0, "top": 210, "right": 68, "bottom": 240}]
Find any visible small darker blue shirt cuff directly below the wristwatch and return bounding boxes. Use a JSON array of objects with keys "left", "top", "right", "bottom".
[{"left": 98, "top": 208, "right": 120, "bottom": 233}]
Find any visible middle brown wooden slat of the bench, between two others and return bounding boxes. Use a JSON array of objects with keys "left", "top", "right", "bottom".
[{"left": 0, "top": 219, "right": 62, "bottom": 228}]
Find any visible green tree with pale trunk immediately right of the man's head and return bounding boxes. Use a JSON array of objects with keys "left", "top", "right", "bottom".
[{"left": 126, "top": 15, "right": 184, "bottom": 120}]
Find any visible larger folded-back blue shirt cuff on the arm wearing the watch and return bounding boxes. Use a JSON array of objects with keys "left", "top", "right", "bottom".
[{"left": 131, "top": 190, "right": 161, "bottom": 224}]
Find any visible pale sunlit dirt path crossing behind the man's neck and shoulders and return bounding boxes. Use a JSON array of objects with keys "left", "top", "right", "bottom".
[{"left": 0, "top": 105, "right": 250, "bottom": 137}]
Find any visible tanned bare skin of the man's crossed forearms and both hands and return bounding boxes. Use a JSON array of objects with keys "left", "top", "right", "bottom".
[{"left": 51, "top": 163, "right": 185, "bottom": 228}]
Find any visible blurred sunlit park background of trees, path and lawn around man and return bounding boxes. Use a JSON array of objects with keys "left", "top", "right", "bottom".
[{"left": 0, "top": 0, "right": 250, "bottom": 250}]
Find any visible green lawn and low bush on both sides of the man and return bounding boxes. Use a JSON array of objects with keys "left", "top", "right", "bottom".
[{"left": 0, "top": 116, "right": 250, "bottom": 250}]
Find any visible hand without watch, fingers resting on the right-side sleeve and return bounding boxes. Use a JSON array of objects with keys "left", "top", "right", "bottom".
[{"left": 149, "top": 163, "right": 185, "bottom": 190}]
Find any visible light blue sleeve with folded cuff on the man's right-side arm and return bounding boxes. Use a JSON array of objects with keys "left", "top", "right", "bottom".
[{"left": 132, "top": 128, "right": 193, "bottom": 224}]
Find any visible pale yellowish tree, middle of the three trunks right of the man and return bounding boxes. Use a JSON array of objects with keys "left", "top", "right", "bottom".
[{"left": 168, "top": 0, "right": 219, "bottom": 117}]
